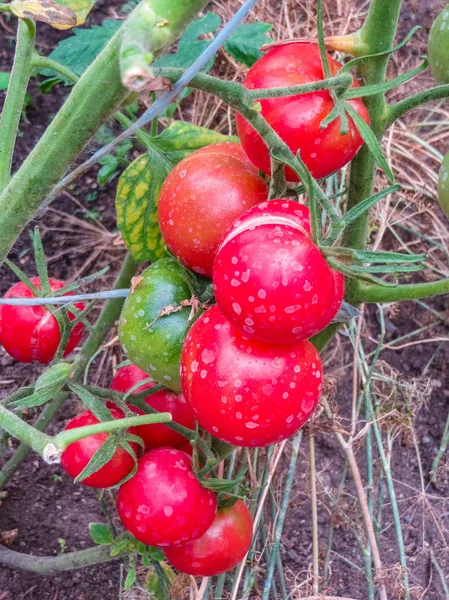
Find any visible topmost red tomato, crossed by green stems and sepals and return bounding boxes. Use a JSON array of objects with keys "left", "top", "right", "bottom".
[{"left": 237, "top": 42, "right": 369, "bottom": 181}]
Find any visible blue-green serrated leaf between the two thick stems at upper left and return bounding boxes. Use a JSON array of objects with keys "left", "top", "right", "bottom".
[{"left": 40, "top": 19, "right": 122, "bottom": 78}]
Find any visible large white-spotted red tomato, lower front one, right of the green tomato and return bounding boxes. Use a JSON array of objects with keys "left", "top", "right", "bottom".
[{"left": 181, "top": 306, "right": 323, "bottom": 447}]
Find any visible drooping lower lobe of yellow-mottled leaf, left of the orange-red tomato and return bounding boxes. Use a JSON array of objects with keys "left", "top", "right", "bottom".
[{"left": 115, "top": 153, "right": 170, "bottom": 263}]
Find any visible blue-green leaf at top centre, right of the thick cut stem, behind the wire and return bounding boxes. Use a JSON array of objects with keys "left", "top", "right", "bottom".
[{"left": 154, "top": 12, "right": 221, "bottom": 73}]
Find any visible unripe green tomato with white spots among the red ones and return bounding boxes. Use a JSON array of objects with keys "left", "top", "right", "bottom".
[{"left": 118, "top": 258, "right": 192, "bottom": 392}]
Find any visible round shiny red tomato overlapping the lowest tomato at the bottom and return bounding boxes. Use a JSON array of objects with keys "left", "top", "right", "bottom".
[{"left": 117, "top": 448, "right": 217, "bottom": 547}]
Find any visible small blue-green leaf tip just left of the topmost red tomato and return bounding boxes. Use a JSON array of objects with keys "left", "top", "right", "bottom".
[{"left": 224, "top": 22, "right": 273, "bottom": 67}]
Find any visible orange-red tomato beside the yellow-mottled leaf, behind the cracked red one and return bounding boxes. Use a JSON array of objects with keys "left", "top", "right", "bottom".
[{"left": 158, "top": 143, "right": 268, "bottom": 277}]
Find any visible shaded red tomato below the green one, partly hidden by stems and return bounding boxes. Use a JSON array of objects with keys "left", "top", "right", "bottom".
[{"left": 108, "top": 365, "right": 195, "bottom": 450}]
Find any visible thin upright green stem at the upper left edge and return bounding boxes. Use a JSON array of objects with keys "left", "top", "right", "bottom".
[{"left": 0, "top": 19, "right": 36, "bottom": 194}]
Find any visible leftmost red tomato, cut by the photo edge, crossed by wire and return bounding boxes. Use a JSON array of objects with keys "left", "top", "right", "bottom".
[{"left": 0, "top": 277, "right": 84, "bottom": 364}]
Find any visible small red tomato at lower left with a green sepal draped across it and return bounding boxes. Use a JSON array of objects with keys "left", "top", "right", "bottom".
[{"left": 61, "top": 407, "right": 140, "bottom": 488}]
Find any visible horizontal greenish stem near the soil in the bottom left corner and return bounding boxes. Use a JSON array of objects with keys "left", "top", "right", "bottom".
[{"left": 0, "top": 545, "right": 121, "bottom": 575}]
